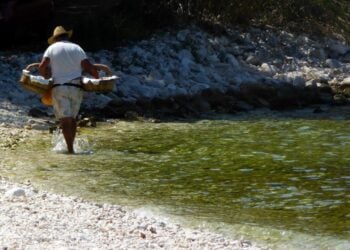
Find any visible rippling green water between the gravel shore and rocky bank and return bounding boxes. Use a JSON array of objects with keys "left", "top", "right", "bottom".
[{"left": 0, "top": 110, "right": 350, "bottom": 249}]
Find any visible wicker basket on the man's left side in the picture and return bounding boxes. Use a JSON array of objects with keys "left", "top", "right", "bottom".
[{"left": 19, "top": 63, "right": 52, "bottom": 95}]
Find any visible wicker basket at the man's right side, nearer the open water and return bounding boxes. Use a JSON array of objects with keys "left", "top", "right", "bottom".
[{"left": 82, "top": 64, "right": 118, "bottom": 93}]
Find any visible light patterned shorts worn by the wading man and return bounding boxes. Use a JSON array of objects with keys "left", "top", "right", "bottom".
[{"left": 52, "top": 86, "right": 84, "bottom": 119}]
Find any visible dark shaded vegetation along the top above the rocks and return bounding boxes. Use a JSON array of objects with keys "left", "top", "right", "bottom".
[{"left": 0, "top": 0, "right": 350, "bottom": 49}]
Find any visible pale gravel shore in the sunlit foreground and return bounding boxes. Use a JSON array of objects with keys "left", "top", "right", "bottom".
[{"left": 0, "top": 178, "right": 262, "bottom": 249}]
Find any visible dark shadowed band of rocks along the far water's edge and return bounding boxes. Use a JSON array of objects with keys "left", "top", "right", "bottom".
[{"left": 79, "top": 84, "right": 334, "bottom": 120}]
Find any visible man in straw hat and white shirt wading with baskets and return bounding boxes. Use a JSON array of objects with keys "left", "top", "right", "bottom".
[{"left": 39, "top": 26, "right": 99, "bottom": 154}]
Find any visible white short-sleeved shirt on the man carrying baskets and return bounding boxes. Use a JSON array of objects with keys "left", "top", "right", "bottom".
[{"left": 44, "top": 41, "right": 87, "bottom": 84}]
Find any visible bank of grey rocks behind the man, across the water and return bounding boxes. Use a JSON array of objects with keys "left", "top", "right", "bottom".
[{"left": 0, "top": 27, "right": 350, "bottom": 125}]
